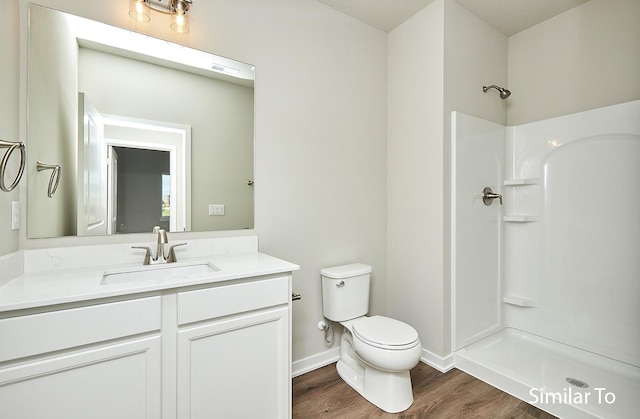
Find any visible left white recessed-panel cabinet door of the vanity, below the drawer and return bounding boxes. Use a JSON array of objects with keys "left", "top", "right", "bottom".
[{"left": 0, "top": 335, "right": 160, "bottom": 419}]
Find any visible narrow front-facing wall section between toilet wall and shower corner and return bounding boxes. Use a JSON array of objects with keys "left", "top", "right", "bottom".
[{"left": 387, "top": 0, "right": 444, "bottom": 364}]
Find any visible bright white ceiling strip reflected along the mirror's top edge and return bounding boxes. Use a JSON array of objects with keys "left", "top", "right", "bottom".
[{"left": 69, "top": 16, "right": 255, "bottom": 80}]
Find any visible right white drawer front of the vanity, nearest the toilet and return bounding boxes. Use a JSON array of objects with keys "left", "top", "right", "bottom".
[{"left": 178, "top": 276, "right": 291, "bottom": 325}]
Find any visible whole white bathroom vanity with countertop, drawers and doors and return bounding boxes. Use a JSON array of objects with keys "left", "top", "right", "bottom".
[{"left": 0, "top": 238, "right": 298, "bottom": 419}]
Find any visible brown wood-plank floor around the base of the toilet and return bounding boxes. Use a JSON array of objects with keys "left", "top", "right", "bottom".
[{"left": 293, "top": 362, "right": 555, "bottom": 419}]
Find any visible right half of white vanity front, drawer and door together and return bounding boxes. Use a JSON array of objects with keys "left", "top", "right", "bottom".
[{"left": 171, "top": 275, "right": 291, "bottom": 419}]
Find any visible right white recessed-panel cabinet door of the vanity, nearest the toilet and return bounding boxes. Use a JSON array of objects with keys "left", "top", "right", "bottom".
[{"left": 177, "top": 306, "right": 291, "bottom": 419}]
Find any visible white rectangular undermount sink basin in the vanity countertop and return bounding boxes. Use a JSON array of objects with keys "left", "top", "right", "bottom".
[{"left": 100, "top": 262, "right": 220, "bottom": 285}]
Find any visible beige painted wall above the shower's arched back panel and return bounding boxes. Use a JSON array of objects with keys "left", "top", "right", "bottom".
[{"left": 508, "top": 0, "right": 640, "bottom": 125}]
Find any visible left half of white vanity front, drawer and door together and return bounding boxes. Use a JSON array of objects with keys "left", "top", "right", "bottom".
[{"left": 0, "top": 296, "right": 161, "bottom": 419}]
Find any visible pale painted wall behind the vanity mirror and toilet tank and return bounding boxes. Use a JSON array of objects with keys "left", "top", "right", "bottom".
[{"left": 13, "top": 0, "right": 387, "bottom": 368}]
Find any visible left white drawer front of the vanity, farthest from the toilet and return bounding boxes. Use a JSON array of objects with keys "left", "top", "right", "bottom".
[{"left": 0, "top": 296, "right": 161, "bottom": 362}]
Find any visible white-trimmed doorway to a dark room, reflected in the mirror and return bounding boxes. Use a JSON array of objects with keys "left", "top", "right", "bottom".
[{"left": 102, "top": 114, "right": 191, "bottom": 234}]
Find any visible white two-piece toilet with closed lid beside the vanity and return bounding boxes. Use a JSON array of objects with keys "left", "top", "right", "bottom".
[{"left": 320, "top": 263, "right": 422, "bottom": 413}]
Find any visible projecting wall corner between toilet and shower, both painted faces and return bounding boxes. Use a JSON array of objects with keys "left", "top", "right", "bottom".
[{"left": 387, "top": 0, "right": 507, "bottom": 367}]
